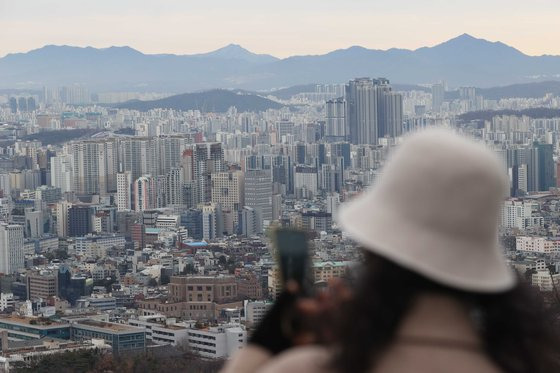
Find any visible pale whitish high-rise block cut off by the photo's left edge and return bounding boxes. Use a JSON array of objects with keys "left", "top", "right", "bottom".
[{"left": 0, "top": 223, "right": 25, "bottom": 274}]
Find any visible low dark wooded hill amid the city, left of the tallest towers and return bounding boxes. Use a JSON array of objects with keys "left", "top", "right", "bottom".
[{"left": 116, "top": 89, "right": 283, "bottom": 113}]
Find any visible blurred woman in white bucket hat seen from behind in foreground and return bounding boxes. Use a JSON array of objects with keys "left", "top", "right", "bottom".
[{"left": 224, "top": 129, "right": 560, "bottom": 373}]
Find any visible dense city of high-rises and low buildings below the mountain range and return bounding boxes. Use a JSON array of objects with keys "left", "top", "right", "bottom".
[{"left": 0, "top": 2, "right": 560, "bottom": 366}]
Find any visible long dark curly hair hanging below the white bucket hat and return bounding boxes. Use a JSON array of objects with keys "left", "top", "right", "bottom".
[{"left": 330, "top": 252, "right": 560, "bottom": 373}]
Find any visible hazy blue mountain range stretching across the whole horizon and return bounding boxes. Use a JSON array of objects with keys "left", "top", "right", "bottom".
[{"left": 0, "top": 34, "right": 560, "bottom": 93}]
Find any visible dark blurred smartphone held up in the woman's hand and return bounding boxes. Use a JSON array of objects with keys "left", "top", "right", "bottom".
[{"left": 273, "top": 228, "right": 310, "bottom": 293}]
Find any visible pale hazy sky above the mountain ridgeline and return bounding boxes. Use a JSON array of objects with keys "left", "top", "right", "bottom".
[{"left": 0, "top": 0, "right": 560, "bottom": 57}]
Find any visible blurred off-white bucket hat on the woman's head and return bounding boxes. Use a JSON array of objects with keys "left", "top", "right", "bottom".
[{"left": 337, "top": 129, "right": 516, "bottom": 293}]
